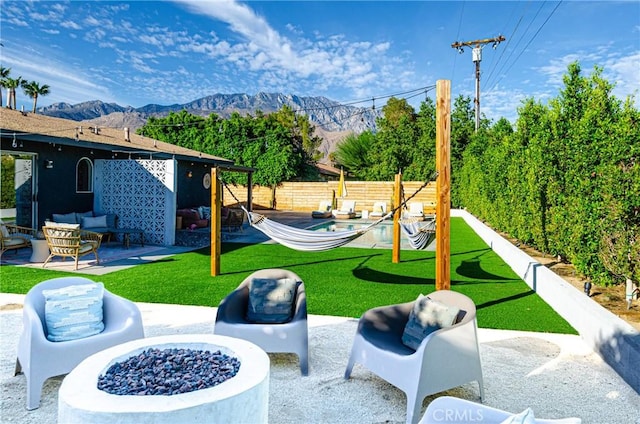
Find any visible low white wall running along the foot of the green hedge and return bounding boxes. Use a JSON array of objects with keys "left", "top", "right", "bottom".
[{"left": 451, "top": 210, "right": 640, "bottom": 393}]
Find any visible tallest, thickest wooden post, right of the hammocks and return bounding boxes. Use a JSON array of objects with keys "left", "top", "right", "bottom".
[{"left": 436, "top": 80, "right": 451, "bottom": 290}]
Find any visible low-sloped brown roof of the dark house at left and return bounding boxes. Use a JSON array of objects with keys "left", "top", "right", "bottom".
[{"left": 0, "top": 107, "right": 233, "bottom": 166}]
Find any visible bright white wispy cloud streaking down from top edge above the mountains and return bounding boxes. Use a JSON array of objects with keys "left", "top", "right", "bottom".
[{"left": 171, "top": 1, "right": 407, "bottom": 99}]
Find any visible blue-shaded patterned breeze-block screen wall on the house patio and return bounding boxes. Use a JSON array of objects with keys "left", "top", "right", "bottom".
[{"left": 94, "top": 159, "right": 177, "bottom": 246}]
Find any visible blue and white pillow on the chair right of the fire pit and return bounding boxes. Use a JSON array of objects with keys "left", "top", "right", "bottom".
[{"left": 402, "top": 294, "right": 460, "bottom": 350}]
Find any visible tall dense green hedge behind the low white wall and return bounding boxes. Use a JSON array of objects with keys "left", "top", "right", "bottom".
[{"left": 455, "top": 63, "right": 640, "bottom": 284}]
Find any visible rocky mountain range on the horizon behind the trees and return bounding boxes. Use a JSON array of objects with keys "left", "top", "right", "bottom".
[{"left": 38, "top": 93, "right": 381, "bottom": 159}]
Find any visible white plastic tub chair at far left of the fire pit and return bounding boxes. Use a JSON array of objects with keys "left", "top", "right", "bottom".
[{"left": 14, "top": 277, "right": 144, "bottom": 410}]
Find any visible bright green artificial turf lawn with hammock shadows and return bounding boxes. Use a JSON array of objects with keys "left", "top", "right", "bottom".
[{"left": 0, "top": 218, "right": 579, "bottom": 334}]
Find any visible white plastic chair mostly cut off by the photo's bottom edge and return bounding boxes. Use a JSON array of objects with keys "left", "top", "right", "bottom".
[{"left": 419, "top": 396, "right": 582, "bottom": 424}]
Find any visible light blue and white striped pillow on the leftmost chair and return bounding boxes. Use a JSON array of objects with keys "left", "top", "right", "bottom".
[{"left": 42, "top": 283, "right": 104, "bottom": 342}]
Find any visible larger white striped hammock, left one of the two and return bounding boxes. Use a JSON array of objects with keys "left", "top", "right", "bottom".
[{"left": 242, "top": 208, "right": 392, "bottom": 252}]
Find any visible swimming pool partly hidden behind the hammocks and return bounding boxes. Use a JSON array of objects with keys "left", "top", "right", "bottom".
[{"left": 308, "top": 219, "right": 435, "bottom": 250}]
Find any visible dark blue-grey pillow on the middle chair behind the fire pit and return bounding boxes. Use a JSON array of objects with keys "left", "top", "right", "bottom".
[{"left": 247, "top": 278, "right": 297, "bottom": 324}]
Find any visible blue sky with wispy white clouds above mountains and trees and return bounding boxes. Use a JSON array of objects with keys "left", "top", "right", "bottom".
[{"left": 0, "top": 0, "right": 640, "bottom": 120}]
